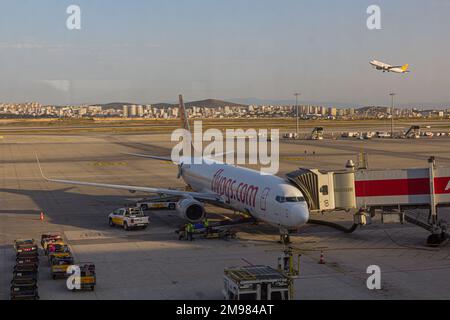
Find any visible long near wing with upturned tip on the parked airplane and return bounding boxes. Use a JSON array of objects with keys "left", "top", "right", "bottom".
[{"left": 36, "top": 156, "right": 222, "bottom": 202}]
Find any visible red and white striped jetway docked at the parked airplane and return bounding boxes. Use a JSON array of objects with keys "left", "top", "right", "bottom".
[{"left": 287, "top": 157, "right": 450, "bottom": 245}]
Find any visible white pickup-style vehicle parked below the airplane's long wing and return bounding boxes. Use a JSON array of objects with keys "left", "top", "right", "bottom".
[{"left": 108, "top": 207, "right": 149, "bottom": 231}]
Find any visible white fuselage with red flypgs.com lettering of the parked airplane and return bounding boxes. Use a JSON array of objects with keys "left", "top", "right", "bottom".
[{"left": 181, "top": 162, "right": 309, "bottom": 229}]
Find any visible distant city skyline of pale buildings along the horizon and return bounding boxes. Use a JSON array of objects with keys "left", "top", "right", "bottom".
[{"left": 0, "top": 100, "right": 450, "bottom": 120}]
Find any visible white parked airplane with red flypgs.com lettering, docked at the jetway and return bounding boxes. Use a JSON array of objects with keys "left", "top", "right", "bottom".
[{"left": 37, "top": 95, "right": 309, "bottom": 243}]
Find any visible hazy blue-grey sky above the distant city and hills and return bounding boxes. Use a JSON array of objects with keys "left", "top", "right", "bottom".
[{"left": 0, "top": 0, "right": 450, "bottom": 105}]
